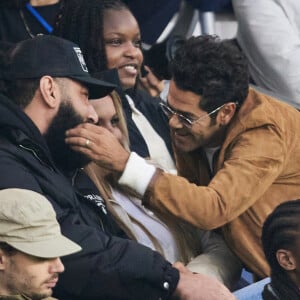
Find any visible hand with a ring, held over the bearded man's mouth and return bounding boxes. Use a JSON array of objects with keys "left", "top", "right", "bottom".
[{"left": 65, "top": 123, "right": 130, "bottom": 172}]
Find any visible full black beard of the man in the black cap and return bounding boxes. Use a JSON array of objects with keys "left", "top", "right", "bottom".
[{"left": 44, "top": 101, "right": 90, "bottom": 172}]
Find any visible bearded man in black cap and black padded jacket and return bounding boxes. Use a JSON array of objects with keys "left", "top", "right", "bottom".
[{"left": 0, "top": 36, "right": 233, "bottom": 300}]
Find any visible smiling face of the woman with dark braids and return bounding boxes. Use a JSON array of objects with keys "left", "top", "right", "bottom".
[{"left": 103, "top": 9, "right": 143, "bottom": 90}]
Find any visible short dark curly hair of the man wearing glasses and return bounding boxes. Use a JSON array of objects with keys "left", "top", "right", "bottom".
[{"left": 171, "top": 35, "right": 249, "bottom": 111}]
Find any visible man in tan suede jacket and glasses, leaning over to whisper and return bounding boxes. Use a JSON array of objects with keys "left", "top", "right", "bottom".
[{"left": 66, "top": 36, "right": 300, "bottom": 278}]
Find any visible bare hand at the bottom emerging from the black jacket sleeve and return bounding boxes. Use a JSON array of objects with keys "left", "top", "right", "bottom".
[{"left": 173, "top": 262, "right": 236, "bottom": 300}]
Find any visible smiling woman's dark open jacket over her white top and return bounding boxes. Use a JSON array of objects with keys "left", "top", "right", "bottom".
[{"left": 121, "top": 90, "right": 173, "bottom": 157}]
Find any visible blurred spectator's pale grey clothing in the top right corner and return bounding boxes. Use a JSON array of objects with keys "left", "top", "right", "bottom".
[{"left": 232, "top": 0, "right": 300, "bottom": 109}]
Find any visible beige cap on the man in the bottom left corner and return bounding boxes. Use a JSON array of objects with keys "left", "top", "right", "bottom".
[{"left": 0, "top": 189, "right": 81, "bottom": 258}]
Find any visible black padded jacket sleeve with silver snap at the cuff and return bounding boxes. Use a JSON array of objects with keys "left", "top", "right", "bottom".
[{"left": 54, "top": 214, "right": 179, "bottom": 300}]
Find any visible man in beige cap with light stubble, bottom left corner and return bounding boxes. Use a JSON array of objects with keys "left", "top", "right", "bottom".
[{"left": 0, "top": 189, "right": 81, "bottom": 300}]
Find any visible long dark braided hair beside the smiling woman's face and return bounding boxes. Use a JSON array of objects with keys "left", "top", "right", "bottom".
[{"left": 53, "top": 0, "right": 129, "bottom": 74}]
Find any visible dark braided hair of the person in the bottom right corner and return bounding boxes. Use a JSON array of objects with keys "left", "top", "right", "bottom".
[{"left": 262, "top": 199, "right": 300, "bottom": 300}]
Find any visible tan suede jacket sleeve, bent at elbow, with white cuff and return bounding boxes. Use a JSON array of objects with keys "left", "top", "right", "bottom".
[{"left": 119, "top": 126, "right": 286, "bottom": 230}]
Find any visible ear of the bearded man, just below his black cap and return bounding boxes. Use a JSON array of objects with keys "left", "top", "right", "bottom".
[{"left": 40, "top": 76, "right": 60, "bottom": 108}]
